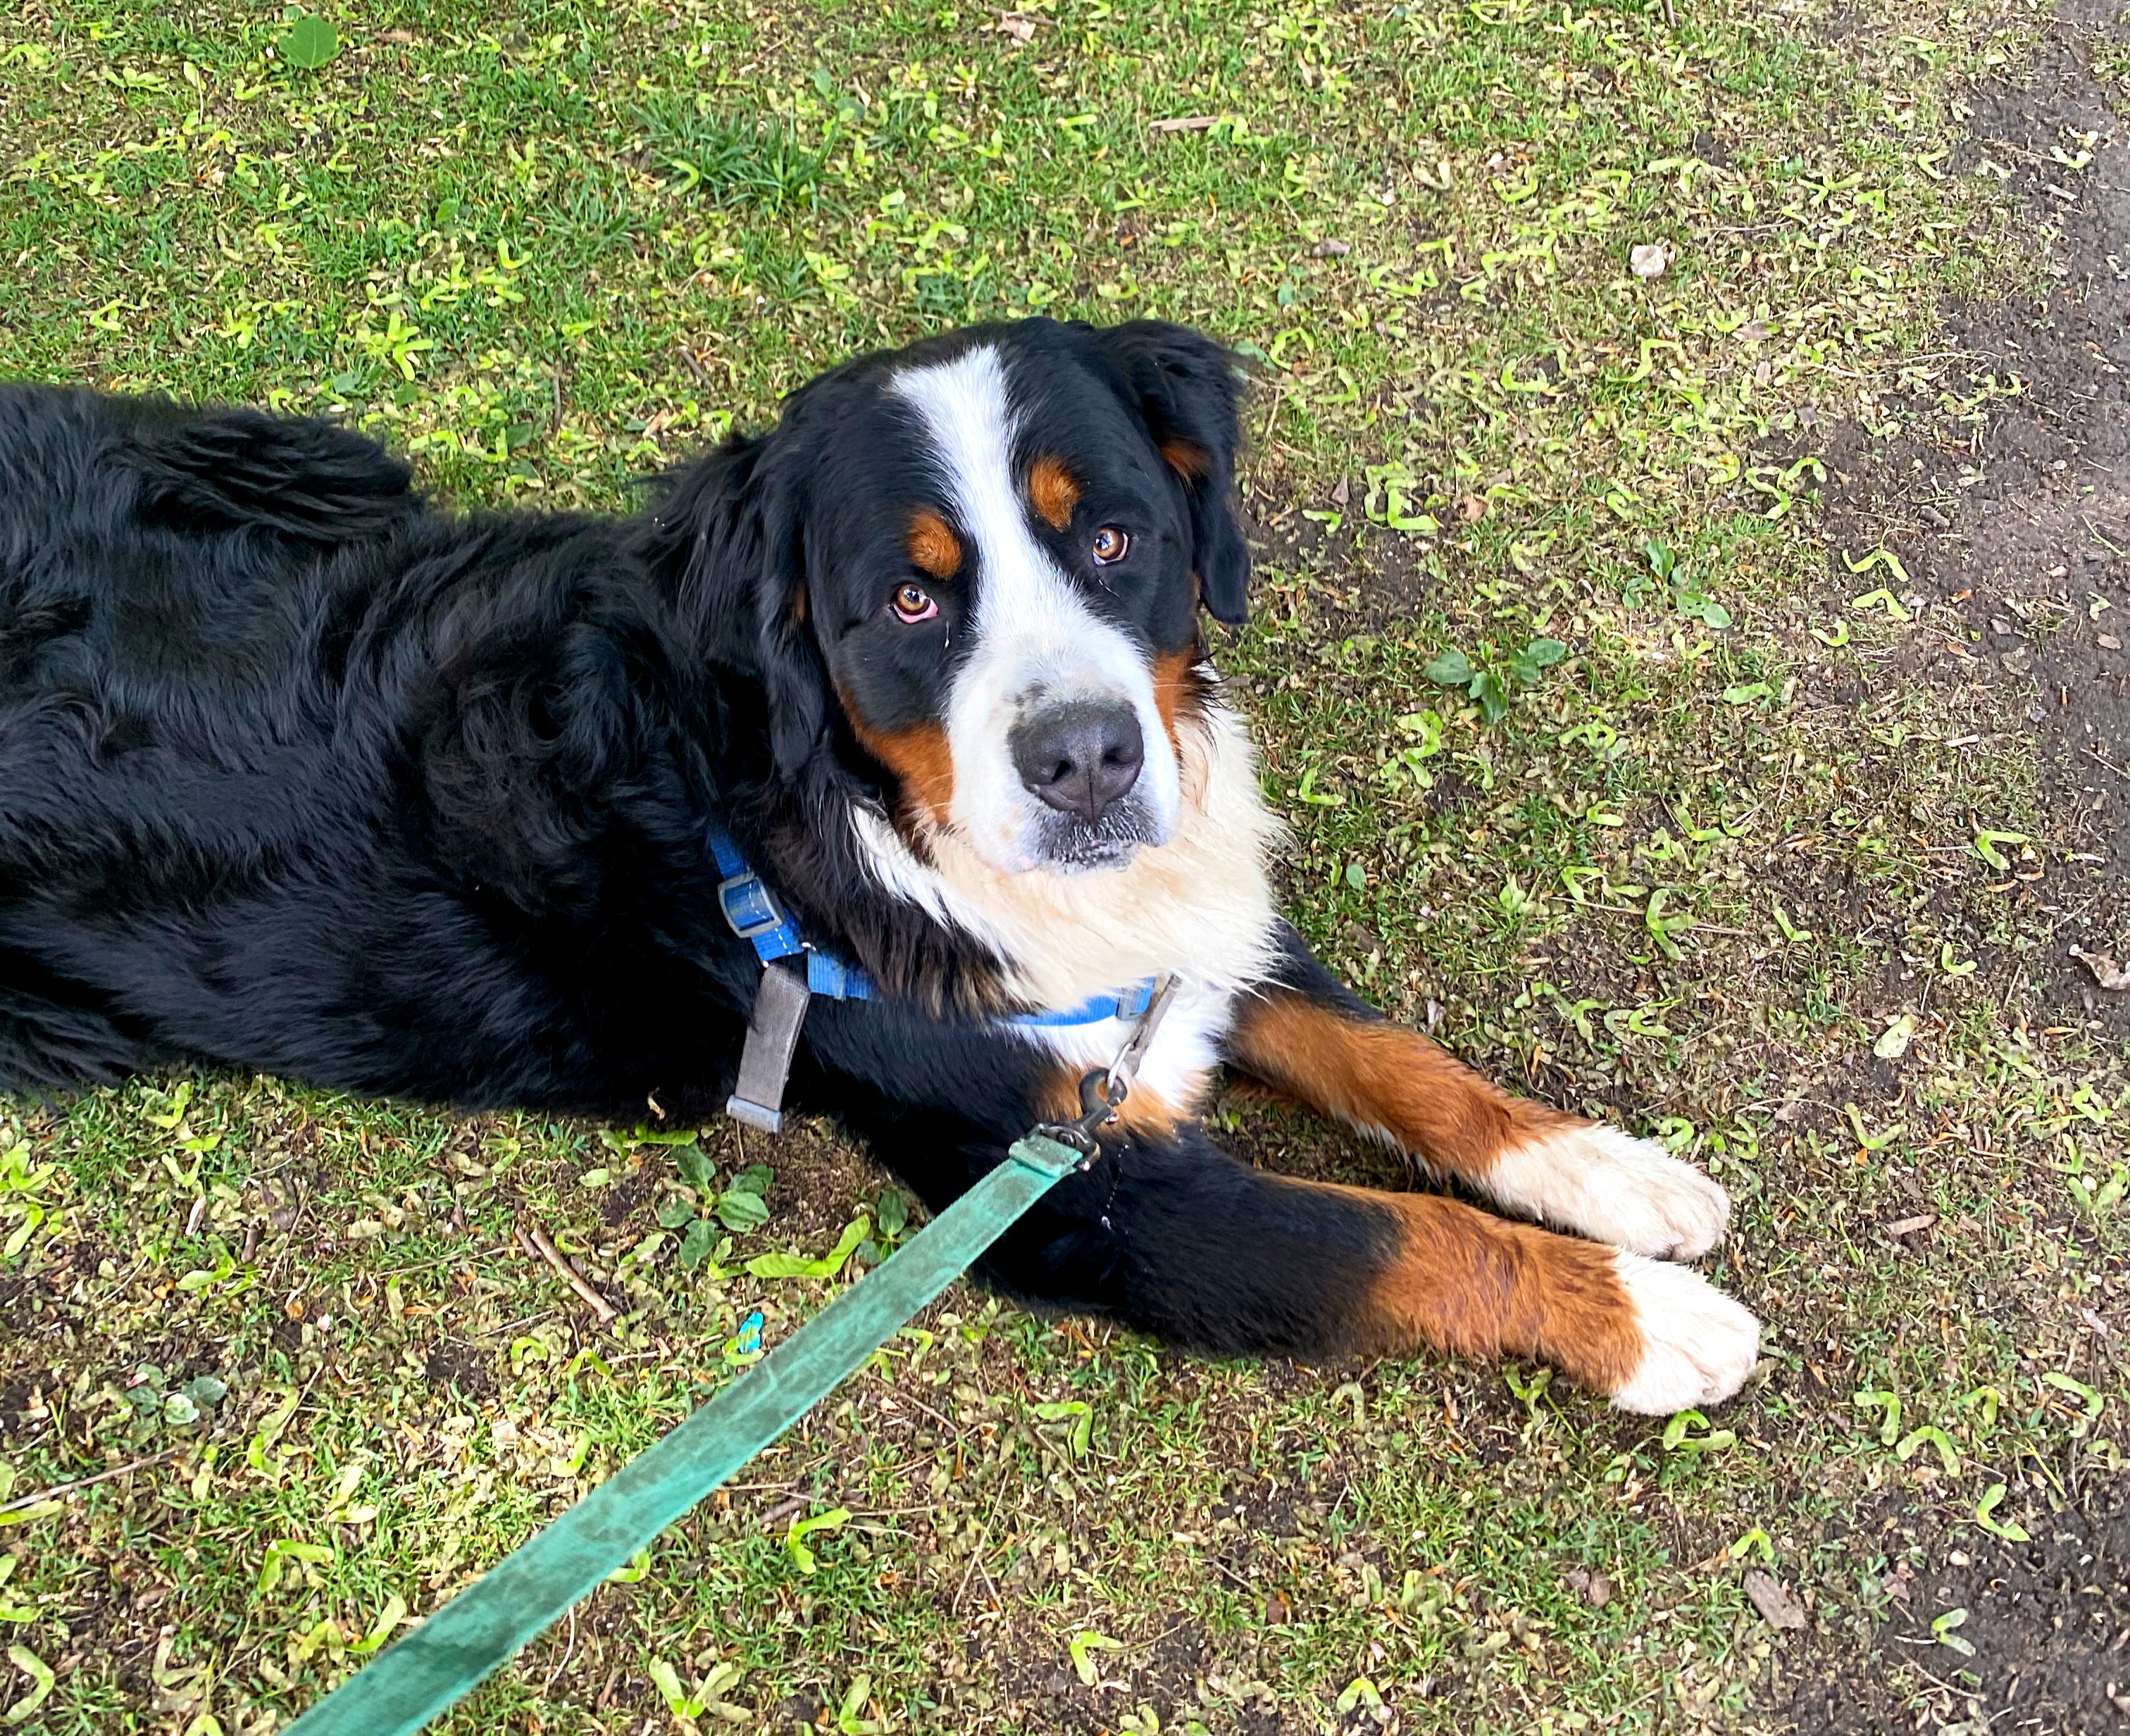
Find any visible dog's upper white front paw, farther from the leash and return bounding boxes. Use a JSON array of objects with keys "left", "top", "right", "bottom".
[{"left": 1485, "top": 1127, "right": 1729, "bottom": 1259}]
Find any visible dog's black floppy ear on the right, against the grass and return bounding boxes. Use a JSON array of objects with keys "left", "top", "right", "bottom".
[{"left": 1097, "top": 320, "right": 1250, "bottom": 626}]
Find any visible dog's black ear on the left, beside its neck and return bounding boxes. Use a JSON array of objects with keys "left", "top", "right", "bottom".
[{"left": 645, "top": 430, "right": 828, "bottom": 778}]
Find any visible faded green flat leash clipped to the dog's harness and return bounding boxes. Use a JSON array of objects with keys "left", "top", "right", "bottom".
[{"left": 287, "top": 1133, "right": 1082, "bottom": 1736}]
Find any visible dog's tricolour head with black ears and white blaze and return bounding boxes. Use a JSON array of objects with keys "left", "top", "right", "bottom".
[{"left": 681, "top": 320, "right": 1248, "bottom": 873}]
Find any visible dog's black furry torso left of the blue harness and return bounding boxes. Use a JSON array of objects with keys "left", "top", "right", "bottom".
[{"left": 0, "top": 387, "right": 741, "bottom": 1101}]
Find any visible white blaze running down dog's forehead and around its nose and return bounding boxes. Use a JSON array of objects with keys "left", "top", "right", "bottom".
[{"left": 892, "top": 345, "right": 1180, "bottom": 871}]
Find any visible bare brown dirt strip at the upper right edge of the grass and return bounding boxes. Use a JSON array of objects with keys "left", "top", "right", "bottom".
[{"left": 1828, "top": 0, "right": 2130, "bottom": 1029}]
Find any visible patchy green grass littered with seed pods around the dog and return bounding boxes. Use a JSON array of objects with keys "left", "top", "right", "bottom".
[{"left": 0, "top": 0, "right": 2130, "bottom": 1736}]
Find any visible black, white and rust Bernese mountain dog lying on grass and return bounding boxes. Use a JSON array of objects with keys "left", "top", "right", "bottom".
[{"left": 0, "top": 320, "right": 1760, "bottom": 1414}]
